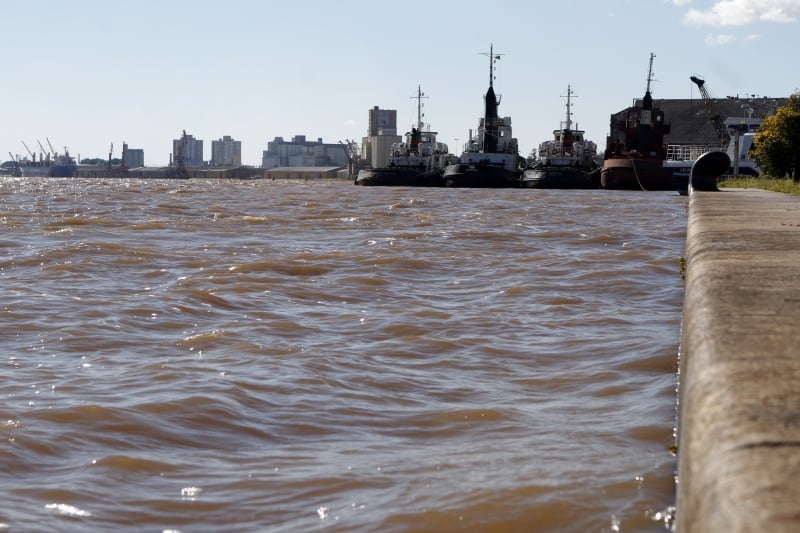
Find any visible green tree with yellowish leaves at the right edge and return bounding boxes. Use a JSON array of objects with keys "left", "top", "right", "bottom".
[{"left": 753, "top": 92, "right": 800, "bottom": 181}]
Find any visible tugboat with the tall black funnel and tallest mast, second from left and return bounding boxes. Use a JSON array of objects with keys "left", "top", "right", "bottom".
[{"left": 442, "top": 46, "right": 522, "bottom": 187}]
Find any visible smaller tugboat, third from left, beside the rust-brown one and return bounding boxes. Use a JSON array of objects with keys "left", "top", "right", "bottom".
[{"left": 522, "top": 85, "right": 599, "bottom": 189}]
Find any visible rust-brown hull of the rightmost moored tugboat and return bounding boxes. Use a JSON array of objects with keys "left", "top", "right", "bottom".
[{"left": 600, "top": 157, "right": 679, "bottom": 191}]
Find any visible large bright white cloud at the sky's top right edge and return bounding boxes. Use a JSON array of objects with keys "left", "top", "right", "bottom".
[{"left": 676, "top": 0, "right": 800, "bottom": 26}]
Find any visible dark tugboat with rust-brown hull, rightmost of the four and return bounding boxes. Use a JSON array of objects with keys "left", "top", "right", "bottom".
[{"left": 600, "top": 53, "right": 676, "bottom": 191}]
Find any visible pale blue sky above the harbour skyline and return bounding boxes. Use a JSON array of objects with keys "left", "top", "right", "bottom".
[{"left": 0, "top": 0, "right": 800, "bottom": 166}]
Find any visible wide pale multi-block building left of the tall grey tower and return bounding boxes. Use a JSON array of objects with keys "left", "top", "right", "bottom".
[{"left": 261, "top": 135, "right": 348, "bottom": 168}]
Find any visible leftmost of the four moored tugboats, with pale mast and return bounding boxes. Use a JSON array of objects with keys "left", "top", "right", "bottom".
[{"left": 355, "top": 86, "right": 448, "bottom": 187}]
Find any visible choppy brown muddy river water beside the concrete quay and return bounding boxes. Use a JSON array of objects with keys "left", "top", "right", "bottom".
[{"left": 0, "top": 178, "right": 687, "bottom": 533}]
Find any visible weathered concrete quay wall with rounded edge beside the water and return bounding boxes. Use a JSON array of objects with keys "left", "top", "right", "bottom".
[{"left": 677, "top": 189, "right": 800, "bottom": 533}]
